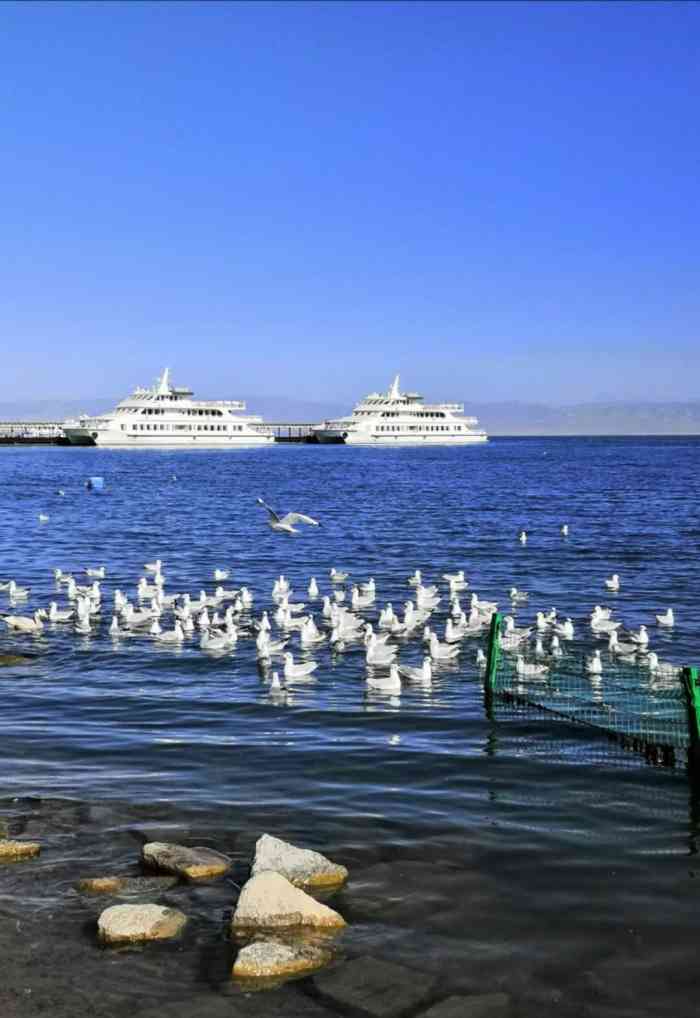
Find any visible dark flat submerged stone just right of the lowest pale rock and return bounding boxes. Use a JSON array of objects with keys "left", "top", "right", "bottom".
[{"left": 313, "top": 956, "right": 434, "bottom": 1018}]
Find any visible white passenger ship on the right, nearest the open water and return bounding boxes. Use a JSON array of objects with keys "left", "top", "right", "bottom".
[{"left": 313, "top": 375, "right": 488, "bottom": 446}]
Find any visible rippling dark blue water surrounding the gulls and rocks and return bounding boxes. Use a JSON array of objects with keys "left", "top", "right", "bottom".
[{"left": 0, "top": 439, "right": 700, "bottom": 1018}]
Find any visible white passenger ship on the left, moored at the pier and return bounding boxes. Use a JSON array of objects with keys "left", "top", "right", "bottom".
[{"left": 63, "top": 367, "right": 275, "bottom": 448}]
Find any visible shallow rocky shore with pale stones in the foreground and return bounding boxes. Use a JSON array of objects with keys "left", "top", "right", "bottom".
[{"left": 0, "top": 799, "right": 694, "bottom": 1018}]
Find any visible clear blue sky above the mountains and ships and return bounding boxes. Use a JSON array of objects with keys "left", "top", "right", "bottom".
[{"left": 0, "top": 2, "right": 700, "bottom": 402}]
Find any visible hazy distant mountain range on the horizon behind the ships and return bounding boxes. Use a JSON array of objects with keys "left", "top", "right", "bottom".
[{"left": 0, "top": 396, "right": 700, "bottom": 435}]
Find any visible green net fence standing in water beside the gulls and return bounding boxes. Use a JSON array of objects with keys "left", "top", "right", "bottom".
[{"left": 486, "top": 618, "right": 700, "bottom": 762}]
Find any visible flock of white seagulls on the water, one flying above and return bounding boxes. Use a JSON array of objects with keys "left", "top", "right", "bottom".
[{"left": 0, "top": 517, "right": 680, "bottom": 696}]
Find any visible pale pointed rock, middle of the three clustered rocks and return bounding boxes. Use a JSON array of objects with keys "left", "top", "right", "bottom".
[{"left": 231, "top": 872, "right": 345, "bottom": 932}]
